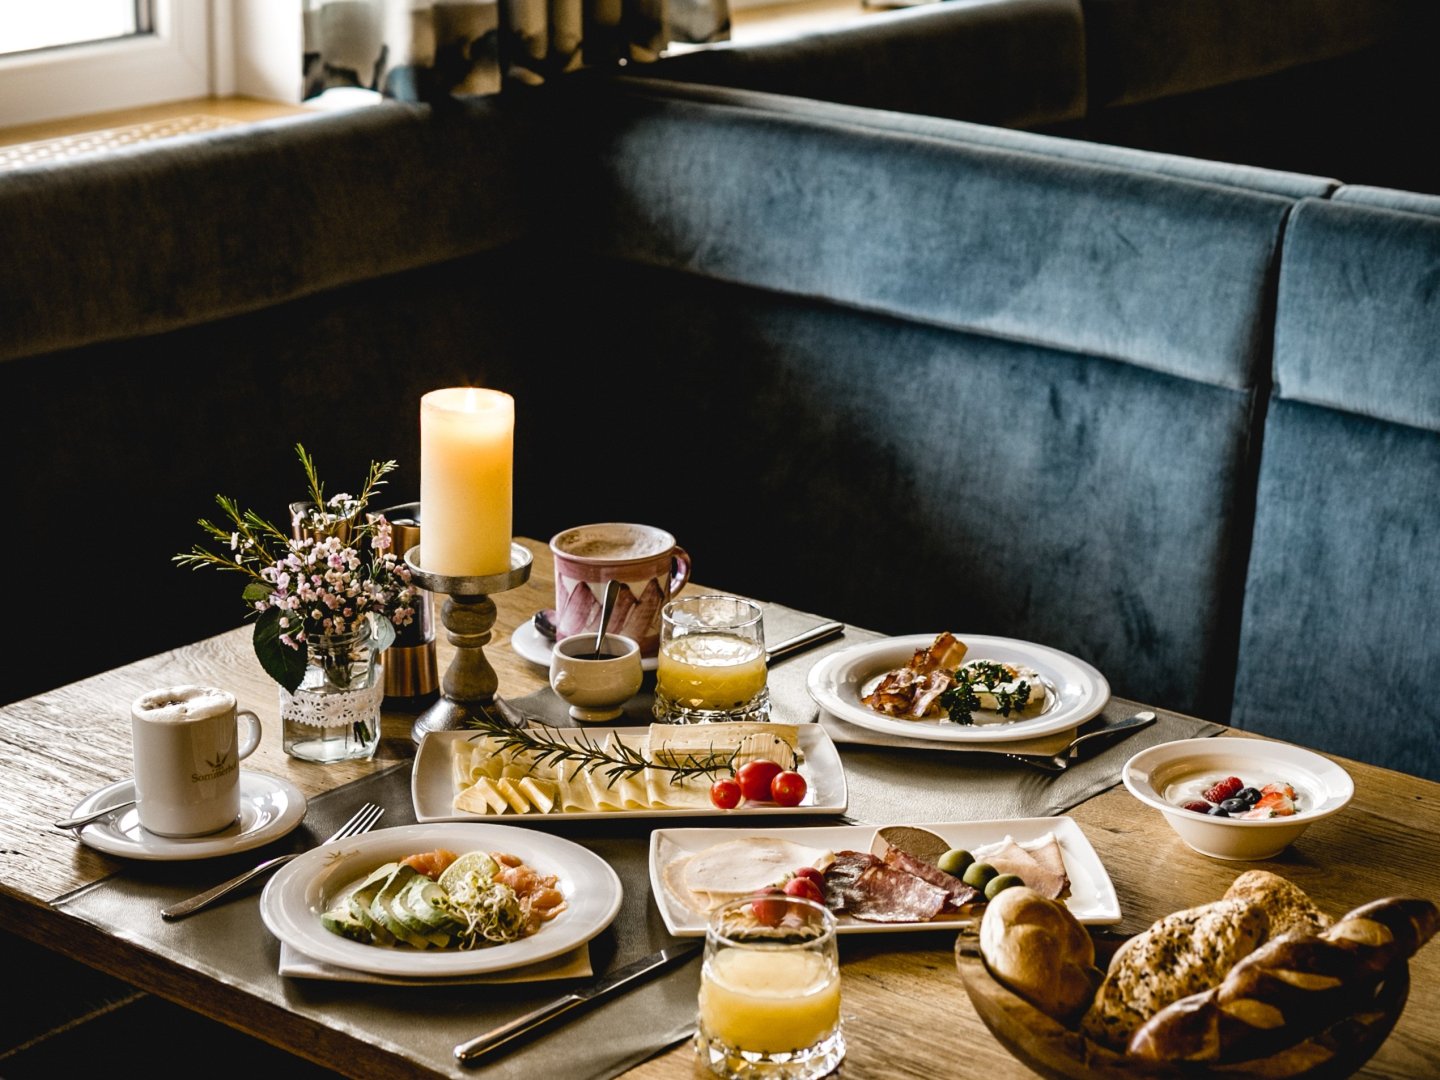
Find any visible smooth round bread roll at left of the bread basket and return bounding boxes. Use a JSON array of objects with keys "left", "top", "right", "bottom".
[{"left": 981, "top": 886, "right": 1102, "bottom": 1022}]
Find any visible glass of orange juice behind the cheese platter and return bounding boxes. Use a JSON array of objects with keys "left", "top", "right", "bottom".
[{"left": 652, "top": 595, "right": 770, "bottom": 724}]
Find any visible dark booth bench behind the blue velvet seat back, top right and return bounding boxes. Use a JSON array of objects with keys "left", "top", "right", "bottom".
[{"left": 648, "top": 0, "right": 1440, "bottom": 194}]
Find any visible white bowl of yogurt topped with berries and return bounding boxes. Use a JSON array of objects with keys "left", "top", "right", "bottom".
[{"left": 1120, "top": 736, "right": 1355, "bottom": 861}]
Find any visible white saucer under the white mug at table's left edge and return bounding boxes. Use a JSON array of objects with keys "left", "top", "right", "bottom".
[{"left": 71, "top": 769, "right": 305, "bottom": 860}]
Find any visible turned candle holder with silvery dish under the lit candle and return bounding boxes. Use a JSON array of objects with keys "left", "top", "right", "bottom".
[{"left": 405, "top": 543, "right": 534, "bottom": 743}]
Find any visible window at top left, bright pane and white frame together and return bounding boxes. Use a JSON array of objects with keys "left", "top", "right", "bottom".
[{"left": 0, "top": 0, "right": 210, "bottom": 127}]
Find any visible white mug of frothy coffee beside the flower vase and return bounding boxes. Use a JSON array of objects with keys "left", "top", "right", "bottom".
[{"left": 130, "top": 685, "right": 261, "bottom": 837}]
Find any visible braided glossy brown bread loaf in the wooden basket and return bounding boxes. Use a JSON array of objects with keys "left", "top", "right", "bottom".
[{"left": 1129, "top": 897, "right": 1440, "bottom": 1063}]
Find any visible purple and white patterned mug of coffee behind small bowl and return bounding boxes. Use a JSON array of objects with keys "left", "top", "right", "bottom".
[{"left": 550, "top": 521, "right": 690, "bottom": 660}]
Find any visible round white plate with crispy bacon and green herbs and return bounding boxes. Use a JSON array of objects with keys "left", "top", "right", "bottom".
[{"left": 805, "top": 634, "right": 1110, "bottom": 743}]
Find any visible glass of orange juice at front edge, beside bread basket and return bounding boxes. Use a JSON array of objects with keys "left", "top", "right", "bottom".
[{"left": 696, "top": 894, "right": 845, "bottom": 1080}]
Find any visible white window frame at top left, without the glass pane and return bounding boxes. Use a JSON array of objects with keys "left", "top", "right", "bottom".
[{"left": 0, "top": 0, "right": 213, "bottom": 127}]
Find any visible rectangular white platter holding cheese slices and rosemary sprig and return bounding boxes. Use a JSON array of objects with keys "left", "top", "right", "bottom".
[{"left": 410, "top": 724, "right": 850, "bottom": 825}]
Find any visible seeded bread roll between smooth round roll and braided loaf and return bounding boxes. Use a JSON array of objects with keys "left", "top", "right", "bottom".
[{"left": 1082, "top": 893, "right": 1270, "bottom": 1050}]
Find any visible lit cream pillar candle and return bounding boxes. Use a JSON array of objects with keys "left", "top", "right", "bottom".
[{"left": 420, "top": 386, "right": 516, "bottom": 577}]
